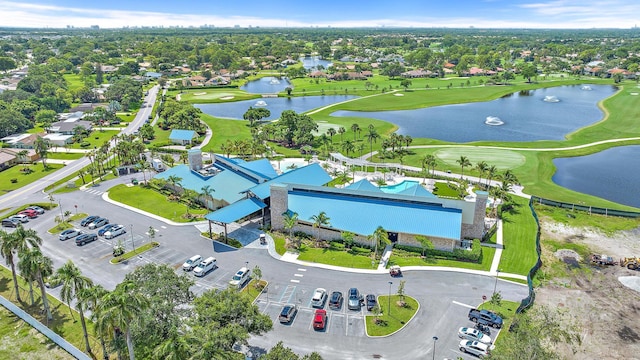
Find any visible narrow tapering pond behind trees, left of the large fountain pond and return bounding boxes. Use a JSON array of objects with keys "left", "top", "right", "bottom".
[{"left": 194, "top": 95, "right": 356, "bottom": 120}]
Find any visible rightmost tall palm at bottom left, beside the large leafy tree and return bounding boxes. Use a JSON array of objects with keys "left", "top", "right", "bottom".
[{"left": 97, "top": 281, "right": 149, "bottom": 360}]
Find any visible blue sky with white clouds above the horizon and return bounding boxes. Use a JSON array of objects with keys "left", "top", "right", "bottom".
[{"left": 0, "top": 0, "right": 640, "bottom": 29}]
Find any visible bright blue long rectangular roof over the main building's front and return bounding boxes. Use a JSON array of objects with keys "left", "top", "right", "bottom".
[{"left": 289, "top": 190, "right": 462, "bottom": 240}]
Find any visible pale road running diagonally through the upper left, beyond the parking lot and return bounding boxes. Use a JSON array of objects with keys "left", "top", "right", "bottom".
[{"left": 0, "top": 85, "right": 160, "bottom": 209}]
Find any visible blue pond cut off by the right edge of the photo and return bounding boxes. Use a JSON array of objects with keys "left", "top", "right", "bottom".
[{"left": 552, "top": 145, "right": 640, "bottom": 208}]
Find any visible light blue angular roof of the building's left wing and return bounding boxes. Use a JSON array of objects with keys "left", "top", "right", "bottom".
[{"left": 154, "top": 165, "right": 256, "bottom": 204}]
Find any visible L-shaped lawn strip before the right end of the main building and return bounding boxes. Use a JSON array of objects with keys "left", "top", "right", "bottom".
[{"left": 389, "top": 247, "right": 504, "bottom": 271}]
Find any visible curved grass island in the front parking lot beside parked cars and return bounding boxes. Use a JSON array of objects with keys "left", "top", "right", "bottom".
[{"left": 365, "top": 295, "right": 420, "bottom": 336}]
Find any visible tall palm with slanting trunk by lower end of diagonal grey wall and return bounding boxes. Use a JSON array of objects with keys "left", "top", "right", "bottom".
[{"left": 55, "top": 260, "right": 93, "bottom": 354}]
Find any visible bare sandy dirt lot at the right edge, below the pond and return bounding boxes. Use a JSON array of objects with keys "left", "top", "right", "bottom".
[{"left": 536, "top": 220, "right": 640, "bottom": 359}]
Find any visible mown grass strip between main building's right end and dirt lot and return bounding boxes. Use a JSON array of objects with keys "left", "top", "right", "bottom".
[{"left": 499, "top": 196, "right": 537, "bottom": 275}]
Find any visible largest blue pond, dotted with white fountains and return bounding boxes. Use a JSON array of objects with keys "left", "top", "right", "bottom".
[{"left": 332, "top": 85, "right": 617, "bottom": 142}]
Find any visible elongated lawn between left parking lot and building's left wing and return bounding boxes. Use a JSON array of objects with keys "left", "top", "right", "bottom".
[{"left": 109, "top": 184, "right": 209, "bottom": 222}]
